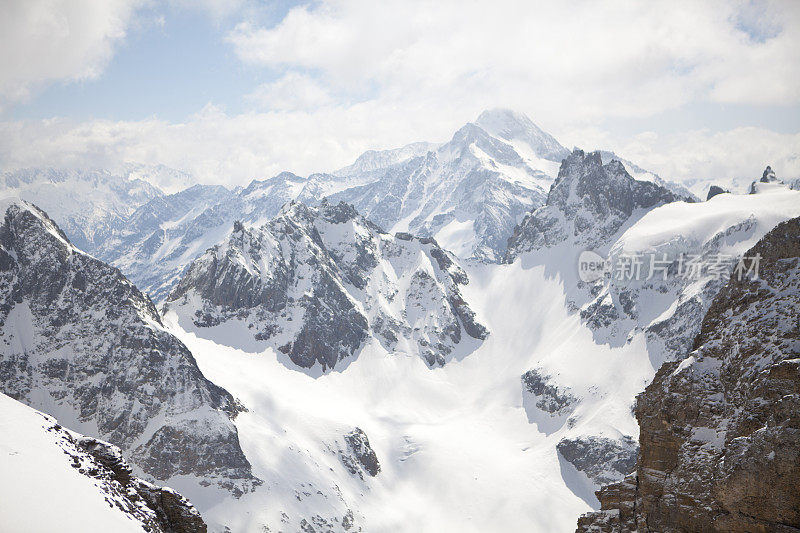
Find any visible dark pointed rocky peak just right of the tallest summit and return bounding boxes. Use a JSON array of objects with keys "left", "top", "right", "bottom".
[{"left": 505, "top": 149, "right": 680, "bottom": 263}]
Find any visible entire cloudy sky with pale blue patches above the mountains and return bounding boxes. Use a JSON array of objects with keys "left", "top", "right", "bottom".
[{"left": 0, "top": 0, "right": 800, "bottom": 188}]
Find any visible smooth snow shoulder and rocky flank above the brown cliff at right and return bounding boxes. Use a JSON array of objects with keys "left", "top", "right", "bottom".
[{"left": 582, "top": 186, "right": 800, "bottom": 365}]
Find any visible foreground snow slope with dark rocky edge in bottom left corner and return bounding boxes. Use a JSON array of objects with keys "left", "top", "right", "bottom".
[{"left": 0, "top": 394, "right": 207, "bottom": 533}]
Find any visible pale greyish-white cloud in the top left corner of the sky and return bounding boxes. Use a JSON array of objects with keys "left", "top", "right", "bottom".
[{"left": 0, "top": 0, "right": 143, "bottom": 108}]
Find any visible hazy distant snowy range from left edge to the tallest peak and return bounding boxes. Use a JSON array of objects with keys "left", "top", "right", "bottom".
[{"left": 18, "top": 109, "right": 569, "bottom": 302}]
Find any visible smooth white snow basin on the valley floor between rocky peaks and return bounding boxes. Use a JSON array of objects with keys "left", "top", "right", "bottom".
[{"left": 161, "top": 255, "right": 653, "bottom": 531}]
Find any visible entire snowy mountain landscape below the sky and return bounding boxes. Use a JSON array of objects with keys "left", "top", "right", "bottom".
[{"left": 0, "top": 109, "right": 800, "bottom": 533}]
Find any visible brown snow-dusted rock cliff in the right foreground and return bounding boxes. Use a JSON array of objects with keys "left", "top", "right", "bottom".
[{"left": 578, "top": 218, "right": 800, "bottom": 531}]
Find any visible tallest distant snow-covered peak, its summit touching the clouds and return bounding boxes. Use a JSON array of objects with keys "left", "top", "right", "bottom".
[{"left": 331, "top": 109, "right": 569, "bottom": 261}]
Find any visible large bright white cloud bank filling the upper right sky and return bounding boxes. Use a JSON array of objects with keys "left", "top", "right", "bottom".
[{"left": 229, "top": 0, "right": 800, "bottom": 122}]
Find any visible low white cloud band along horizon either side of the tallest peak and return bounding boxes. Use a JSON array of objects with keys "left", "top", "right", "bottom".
[{"left": 0, "top": 104, "right": 800, "bottom": 193}]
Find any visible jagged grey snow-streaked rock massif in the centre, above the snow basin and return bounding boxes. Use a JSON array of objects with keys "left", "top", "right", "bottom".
[{"left": 167, "top": 197, "right": 488, "bottom": 371}]
